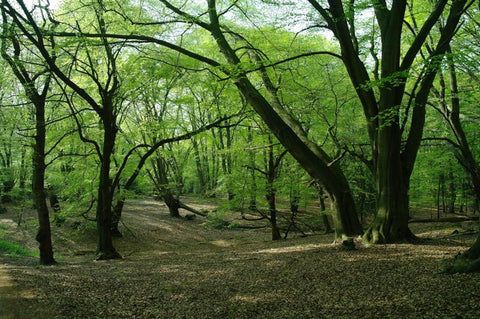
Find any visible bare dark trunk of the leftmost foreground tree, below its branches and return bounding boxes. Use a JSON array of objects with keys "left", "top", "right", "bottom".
[{"left": 32, "top": 102, "right": 55, "bottom": 265}]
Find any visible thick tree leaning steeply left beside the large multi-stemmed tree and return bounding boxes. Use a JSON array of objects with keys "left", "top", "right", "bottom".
[{"left": 144, "top": 0, "right": 362, "bottom": 238}]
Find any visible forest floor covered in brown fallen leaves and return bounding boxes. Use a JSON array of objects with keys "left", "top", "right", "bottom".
[{"left": 0, "top": 199, "right": 480, "bottom": 319}]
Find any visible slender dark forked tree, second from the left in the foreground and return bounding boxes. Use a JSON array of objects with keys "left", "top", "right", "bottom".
[{"left": 2, "top": 0, "right": 127, "bottom": 259}]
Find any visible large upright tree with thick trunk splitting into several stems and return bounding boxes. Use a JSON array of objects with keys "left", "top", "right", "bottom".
[{"left": 308, "top": 0, "right": 473, "bottom": 243}]
